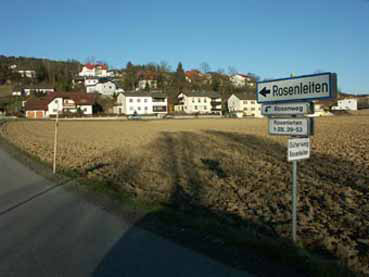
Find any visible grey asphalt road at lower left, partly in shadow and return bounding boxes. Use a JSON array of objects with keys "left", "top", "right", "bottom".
[{"left": 0, "top": 148, "right": 252, "bottom": 277}]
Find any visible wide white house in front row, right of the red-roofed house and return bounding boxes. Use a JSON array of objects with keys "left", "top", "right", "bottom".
[{"left": 114, "top": 91, "right": 168, "bottom": 115}]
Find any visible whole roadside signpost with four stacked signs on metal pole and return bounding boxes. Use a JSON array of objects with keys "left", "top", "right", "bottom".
[{"left": 256, "top": 72, "right": 337, "bottom": 242}]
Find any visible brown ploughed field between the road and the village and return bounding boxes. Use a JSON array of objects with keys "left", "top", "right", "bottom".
[{"left": 2, "top": 116, "right": 369, "bottom": 274}]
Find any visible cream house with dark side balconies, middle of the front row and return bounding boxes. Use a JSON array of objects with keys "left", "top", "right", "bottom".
[{"left": 174, "top": 91, "right": 222, "bottom": 115}]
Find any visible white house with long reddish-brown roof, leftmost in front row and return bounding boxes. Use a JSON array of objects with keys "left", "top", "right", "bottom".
[{"left": 25, "top": 92, "right": 95, "bottom": 119}]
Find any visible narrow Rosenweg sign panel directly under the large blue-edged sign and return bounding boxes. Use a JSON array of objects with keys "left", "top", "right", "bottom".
[{"left": 261, "top": 102, "right": 314, "bottom": 115}]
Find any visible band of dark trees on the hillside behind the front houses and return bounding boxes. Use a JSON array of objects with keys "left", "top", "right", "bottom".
[{"left": 0, "top": 56, "right": 259, "bottom": 99}]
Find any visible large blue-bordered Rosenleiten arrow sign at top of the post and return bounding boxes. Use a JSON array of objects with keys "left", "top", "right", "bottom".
[{"left": 257, "top": 73, "right": 337, "bottom": 103}]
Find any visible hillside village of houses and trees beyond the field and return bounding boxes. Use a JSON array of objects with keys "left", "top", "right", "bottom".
[{"left": 0, "top": 55, "right": 369, "bottom": 119}]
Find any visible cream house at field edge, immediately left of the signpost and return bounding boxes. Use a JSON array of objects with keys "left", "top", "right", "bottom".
[{"left": 227, "top": 93, "right": 263, "bottom": 117}]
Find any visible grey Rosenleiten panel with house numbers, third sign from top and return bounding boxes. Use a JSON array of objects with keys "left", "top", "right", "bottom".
[{"left": 268, "top": 117, "right": 313, "bottom": 136}]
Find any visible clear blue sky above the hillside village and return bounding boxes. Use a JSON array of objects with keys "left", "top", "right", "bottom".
[{"left": 0, "top": 0, "right": 369, "bottom": 94}]
